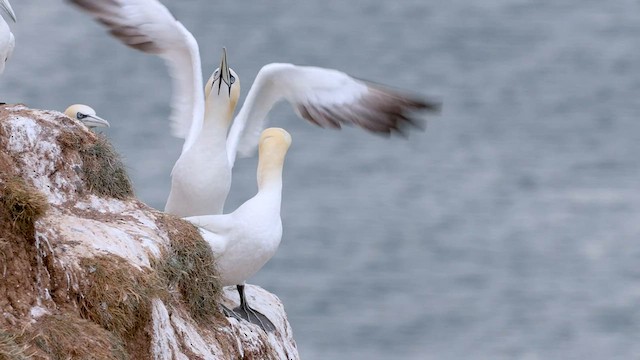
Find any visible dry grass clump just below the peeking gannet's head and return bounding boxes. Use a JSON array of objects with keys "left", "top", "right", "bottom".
[{"left": 58, "top": 132, "right": 133, "bottom": 200}]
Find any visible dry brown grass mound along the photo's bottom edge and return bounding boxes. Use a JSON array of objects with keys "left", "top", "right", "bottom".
[{"left": 29, "top": 314, "right": 130, "bottom": 360}]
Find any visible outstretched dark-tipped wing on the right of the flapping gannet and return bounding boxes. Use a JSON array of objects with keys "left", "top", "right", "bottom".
[{"left": 227, "top": 64, "right": 440, "bottom": 164}]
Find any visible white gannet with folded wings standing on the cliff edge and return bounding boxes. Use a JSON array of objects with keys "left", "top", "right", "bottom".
[{"left": 185, "top": 128, "right": 291, "bottom": 330}]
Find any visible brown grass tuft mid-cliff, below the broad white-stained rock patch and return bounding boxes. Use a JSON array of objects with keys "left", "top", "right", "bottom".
[{"left": 79, "top": 255, "right": 168, "bottom": 341}]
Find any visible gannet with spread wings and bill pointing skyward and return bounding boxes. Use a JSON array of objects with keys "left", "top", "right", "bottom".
[{"left": 69, "top": 0, "right": 439, "bottom": 217}]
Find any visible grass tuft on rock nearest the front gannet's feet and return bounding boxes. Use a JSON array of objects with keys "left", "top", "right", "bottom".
[{"left": 153, "top": 214, "right": 222, "bottom": 324}]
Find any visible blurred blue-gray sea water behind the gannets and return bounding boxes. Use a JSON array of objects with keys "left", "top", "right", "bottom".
[{"left": 0, "top": 0, "right": 640, "bottom": 359}]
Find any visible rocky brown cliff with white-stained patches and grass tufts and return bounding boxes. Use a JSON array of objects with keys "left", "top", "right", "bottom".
[{"left": 0, "top": 105, "right": 298, "bottom": 359}]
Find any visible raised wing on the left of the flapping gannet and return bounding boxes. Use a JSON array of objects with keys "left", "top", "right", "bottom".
[{"left": 68, "top": 0, "right": 204, "bottom": 147}]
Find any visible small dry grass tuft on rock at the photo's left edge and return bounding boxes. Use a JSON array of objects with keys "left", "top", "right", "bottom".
[{"left": 0, "top": 177, "right": 49, "bottom": 238}]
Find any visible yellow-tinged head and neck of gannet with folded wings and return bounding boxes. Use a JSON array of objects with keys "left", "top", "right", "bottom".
[{"left": 258, "top": 128, "right": 291, "bottom": 187}]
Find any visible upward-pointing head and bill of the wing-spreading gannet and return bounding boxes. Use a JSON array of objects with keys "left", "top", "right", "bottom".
[{"left": 204, "top": 48, "right": 240, "bottom": 121}]
